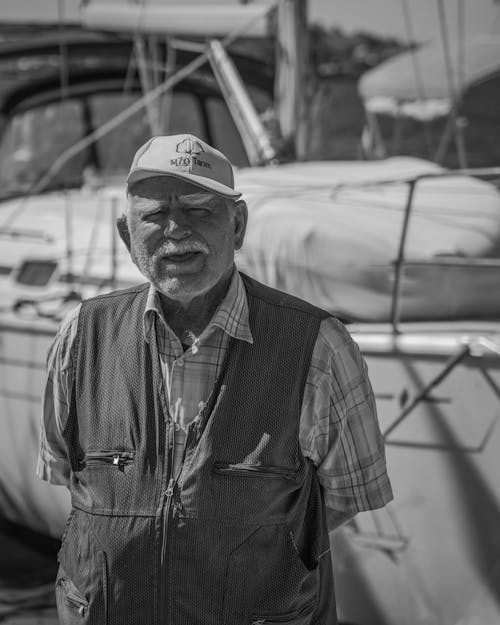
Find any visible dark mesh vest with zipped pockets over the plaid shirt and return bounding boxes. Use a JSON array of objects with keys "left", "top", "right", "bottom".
[{"left": 57, "top": 276, "right": 336, "bottom": 625}]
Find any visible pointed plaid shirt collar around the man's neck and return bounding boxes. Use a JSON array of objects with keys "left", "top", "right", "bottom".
[{"left": 143, "top": 269, "right": 253, "bottom": 343}]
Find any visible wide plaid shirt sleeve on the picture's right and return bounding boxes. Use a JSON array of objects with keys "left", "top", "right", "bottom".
[{"left": 300, "top": 317, "right": 393, "bottom": 518}]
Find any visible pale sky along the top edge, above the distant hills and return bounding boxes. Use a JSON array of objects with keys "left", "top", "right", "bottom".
[{"left": 0, "top": 0, "right": 500, "bottom": 41}]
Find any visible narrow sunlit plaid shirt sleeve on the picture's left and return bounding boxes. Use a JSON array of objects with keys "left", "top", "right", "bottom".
[{"left": 36, "top": 305, "right": 81, "bottom": 486}]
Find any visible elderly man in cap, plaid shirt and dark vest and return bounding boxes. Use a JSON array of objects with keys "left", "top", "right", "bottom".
[{"left": 38, "top": 135, "right": 392, "bottom": 625}]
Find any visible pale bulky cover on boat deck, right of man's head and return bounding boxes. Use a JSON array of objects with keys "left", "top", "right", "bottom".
[{"left": 236, "top": 157, "right": 500, "bottom": 321}]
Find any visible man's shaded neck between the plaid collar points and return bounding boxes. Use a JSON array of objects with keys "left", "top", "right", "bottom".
[{"left": 159, "top": 272, "right": 232, "bottom": 345}]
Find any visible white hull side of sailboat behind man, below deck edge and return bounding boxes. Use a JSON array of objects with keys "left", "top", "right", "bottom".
[{"left": 0, "top": 310, "right": 500, "bottom": 625}]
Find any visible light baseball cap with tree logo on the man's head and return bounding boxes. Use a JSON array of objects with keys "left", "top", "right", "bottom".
[{"left": 127, "top": 134, "right": 241, "bottom": 198}]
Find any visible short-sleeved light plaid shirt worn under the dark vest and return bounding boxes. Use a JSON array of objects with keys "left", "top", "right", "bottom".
[{"left": 37, "top": 271, "right": 392, "bottom": 518}]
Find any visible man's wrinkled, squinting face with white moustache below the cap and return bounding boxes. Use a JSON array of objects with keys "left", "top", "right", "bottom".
[{"left": 122, "top": 177, "right": 247, "bottom": 304}]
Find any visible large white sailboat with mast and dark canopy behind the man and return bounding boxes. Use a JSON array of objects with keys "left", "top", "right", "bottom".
[{"left": 0, "top": 0, "right": 500, "bottom": 625}]
